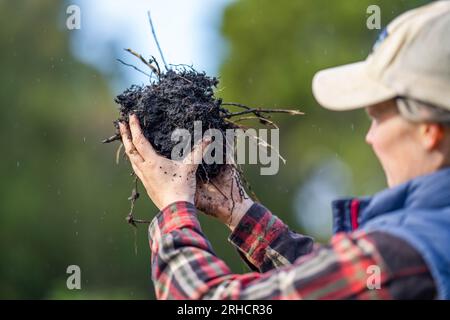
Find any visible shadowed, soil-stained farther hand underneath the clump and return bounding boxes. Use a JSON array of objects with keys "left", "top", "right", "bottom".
[{"left": 195, "top": 164, "right": 254, "bottom": 230}]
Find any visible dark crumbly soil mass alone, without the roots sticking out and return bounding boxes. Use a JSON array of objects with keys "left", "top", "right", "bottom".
[{"left": 115, "top": 68, "right": 236, "bottom": 180}]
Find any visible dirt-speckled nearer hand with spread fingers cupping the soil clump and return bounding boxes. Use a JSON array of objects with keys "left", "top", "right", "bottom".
[{"left": 119, "top": 115, "right": 211, "bottom": 210}]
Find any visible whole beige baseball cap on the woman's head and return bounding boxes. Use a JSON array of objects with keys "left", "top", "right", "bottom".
[{"left": 312, "top": 0, "right": 450, "bottom": 110}]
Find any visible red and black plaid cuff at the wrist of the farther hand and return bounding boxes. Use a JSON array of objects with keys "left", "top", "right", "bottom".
[{"left": 228, "top": 203, "right": 287, "bottom": 268}]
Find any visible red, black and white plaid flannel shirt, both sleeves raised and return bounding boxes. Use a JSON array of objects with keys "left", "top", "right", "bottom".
[{"left": 149, "top": 202, "right": 435, "bottom": 299}]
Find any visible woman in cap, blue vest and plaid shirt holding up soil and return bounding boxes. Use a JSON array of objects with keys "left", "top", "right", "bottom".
[{"left": 120, "top": 1, "right": 450, "bottom": 299}]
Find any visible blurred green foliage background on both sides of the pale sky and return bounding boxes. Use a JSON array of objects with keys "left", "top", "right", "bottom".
[{"left": 0, "top": 0, "right": 426, "bottom": 299}]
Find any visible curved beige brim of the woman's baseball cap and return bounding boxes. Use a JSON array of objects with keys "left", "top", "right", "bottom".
[{"left": 312, "top": 61, "right": 396, "bottom": 111}]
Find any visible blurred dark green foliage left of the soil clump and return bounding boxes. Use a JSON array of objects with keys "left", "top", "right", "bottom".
[{"left": 0, "top": 0, "right": 154, "bottom": 298}]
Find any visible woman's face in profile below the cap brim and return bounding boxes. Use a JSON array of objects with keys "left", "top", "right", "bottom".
[{"left": 366, "top": 100, "right": 424, "bottom": 187}]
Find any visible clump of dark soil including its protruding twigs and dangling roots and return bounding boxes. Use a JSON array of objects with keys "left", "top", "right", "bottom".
[{"left": 103, "top": 49, "right": 302, "bottom": 225}]
